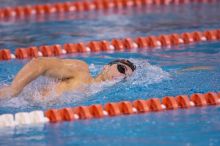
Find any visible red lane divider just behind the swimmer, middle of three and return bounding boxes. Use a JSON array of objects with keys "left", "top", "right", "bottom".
[{"left": 0, "top": 29, "right": 220, "bottom": 61}]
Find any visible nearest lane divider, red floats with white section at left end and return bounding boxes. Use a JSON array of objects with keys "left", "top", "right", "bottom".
[{"left": 0, "top": 92, "right": 220, "bottom": 127}]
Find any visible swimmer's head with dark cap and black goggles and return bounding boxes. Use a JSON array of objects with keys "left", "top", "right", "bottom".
[{"left": 96, "top": 59, "right": 136, "bottom": 81}]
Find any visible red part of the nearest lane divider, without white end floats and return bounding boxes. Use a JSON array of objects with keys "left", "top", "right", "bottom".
[{"left": 45, "top": 92, "right": 220, "bottom": 122}]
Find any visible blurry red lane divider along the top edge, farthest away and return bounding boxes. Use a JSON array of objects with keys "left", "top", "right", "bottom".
[{"left": 0, "top": 0, "right": 218, "bottom": 21}]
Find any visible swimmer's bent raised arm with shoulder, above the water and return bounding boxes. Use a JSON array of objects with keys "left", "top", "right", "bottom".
[{"left": 0, "top": 58, "right": 87, "bottom": 99}]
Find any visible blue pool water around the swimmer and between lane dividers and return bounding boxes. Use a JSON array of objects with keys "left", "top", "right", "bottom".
[{"left": 0, "top": 3, "right": 220, "bottom": 146}]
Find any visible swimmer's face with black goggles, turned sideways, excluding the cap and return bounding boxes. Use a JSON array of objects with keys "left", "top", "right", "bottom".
[{"left": 102, "top": 63, "right": 133, "bottom": 80}]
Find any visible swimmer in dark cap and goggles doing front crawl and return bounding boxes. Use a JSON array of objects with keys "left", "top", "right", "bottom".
[{"left": 0, "top": 57, "right": 136, "bottom": 100}]
